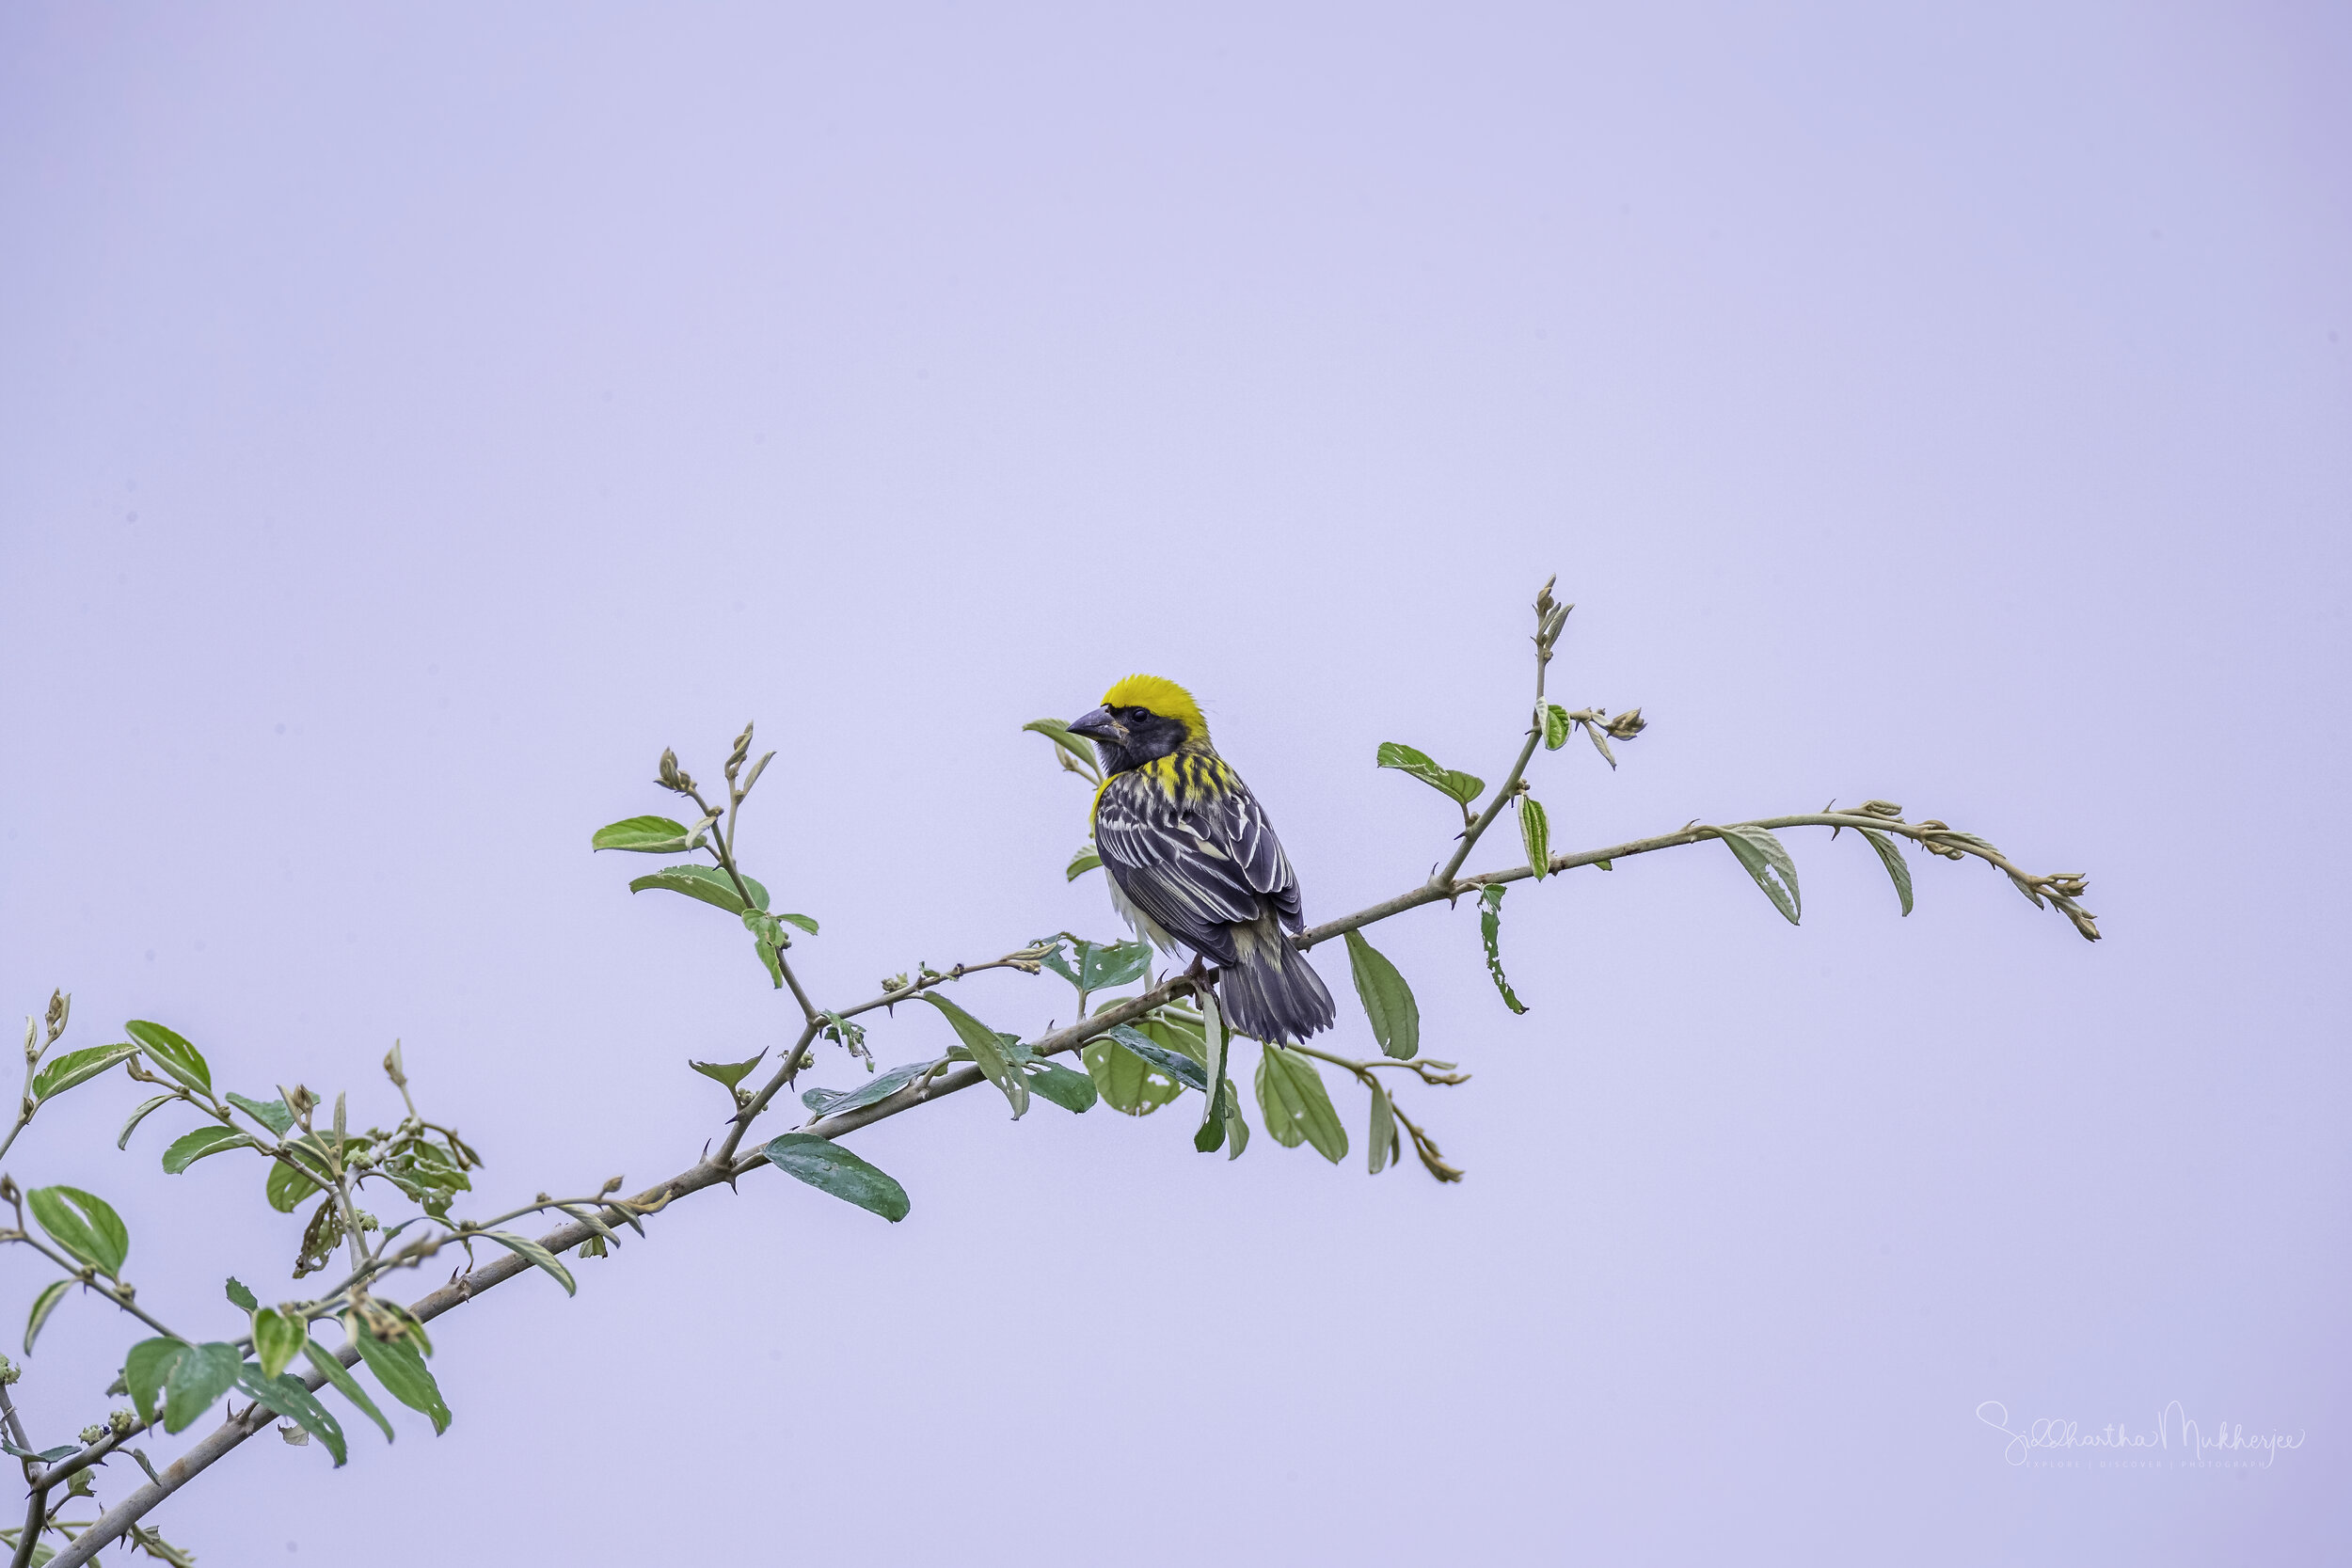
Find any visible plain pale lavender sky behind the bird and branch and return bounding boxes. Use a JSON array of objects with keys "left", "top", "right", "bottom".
[{"left": 0, "top": 5, "right": 2352, "bottom": 1566}]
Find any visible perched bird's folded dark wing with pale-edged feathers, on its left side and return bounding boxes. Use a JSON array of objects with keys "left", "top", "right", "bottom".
[{"left": 1094, "top": 773, "right": 1282, "bottom": 964}]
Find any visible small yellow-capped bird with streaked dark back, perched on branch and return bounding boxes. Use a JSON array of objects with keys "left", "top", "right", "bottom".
[{"left": 1071, "top": 674, "right": 1334, "bottom": 1044}]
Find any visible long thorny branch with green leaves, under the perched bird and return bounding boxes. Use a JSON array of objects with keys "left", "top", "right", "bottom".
[{"left": 0, "top": 585, "right": 2098, "bottom": 1568}]
